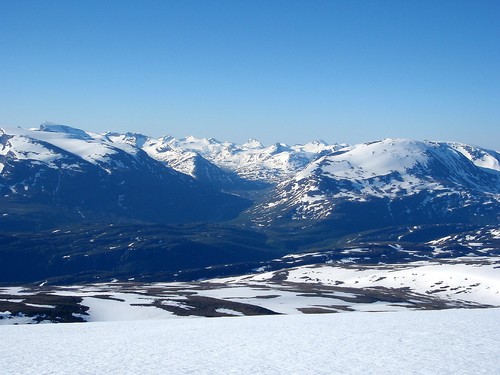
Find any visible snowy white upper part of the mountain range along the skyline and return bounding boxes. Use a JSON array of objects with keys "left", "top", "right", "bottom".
[{"left": 0, "top": 123, "right": 500, "bottom": 189}]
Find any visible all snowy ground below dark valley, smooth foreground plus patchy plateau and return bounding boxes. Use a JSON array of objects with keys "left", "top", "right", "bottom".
[{"left": 0, "top": 254, "right": 500, "bottom": 374}]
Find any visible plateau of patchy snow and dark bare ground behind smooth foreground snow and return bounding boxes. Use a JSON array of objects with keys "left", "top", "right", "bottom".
[{"left": 0, "top": 255, "right": 500, "bottom": 325}]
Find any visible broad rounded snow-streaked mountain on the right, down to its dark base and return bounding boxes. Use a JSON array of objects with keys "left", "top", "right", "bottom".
[{"left": 253, "top": 139, "right": 500, "bottom": 228}]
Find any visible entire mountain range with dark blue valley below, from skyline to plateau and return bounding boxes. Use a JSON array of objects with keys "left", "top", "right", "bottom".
[{"left": 0, "top": 123, "right": 500, "bottom": 281}]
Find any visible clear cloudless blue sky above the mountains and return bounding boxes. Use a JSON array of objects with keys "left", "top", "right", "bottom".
[{"left": 0, "top": 0, "right": 500, "bottom": 150}]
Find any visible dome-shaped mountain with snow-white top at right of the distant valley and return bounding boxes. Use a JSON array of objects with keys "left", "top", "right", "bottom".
[{"left": 255, "top": 139, "right": 500, "bottom": 222}]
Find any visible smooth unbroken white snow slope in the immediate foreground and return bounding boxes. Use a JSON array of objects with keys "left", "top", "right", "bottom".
[{"left": 0, "top": 309, "right": 500, "bottom": 374}]
